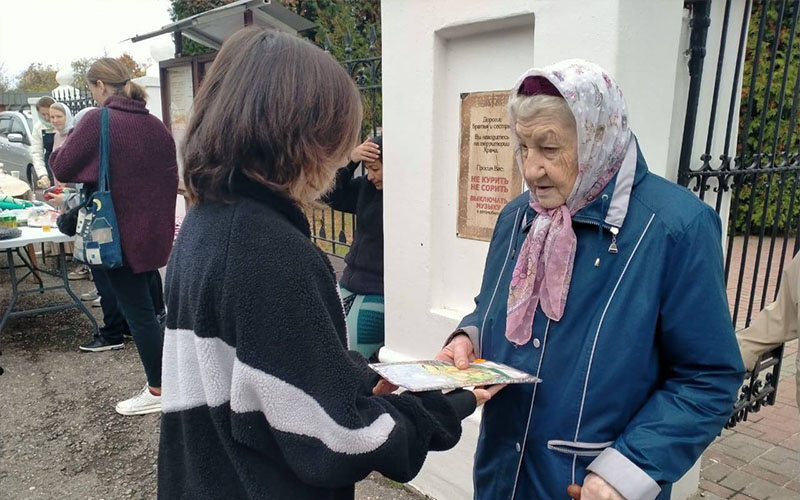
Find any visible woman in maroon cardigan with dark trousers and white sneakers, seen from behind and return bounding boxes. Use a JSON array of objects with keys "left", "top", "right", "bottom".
[{"left": 50, "top": 58, "right": 178, "bottom": 415}]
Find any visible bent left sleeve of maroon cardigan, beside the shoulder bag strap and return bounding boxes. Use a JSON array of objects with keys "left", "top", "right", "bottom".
[{"left": 50, "top": 110, "right": 100, "bottom": 184}]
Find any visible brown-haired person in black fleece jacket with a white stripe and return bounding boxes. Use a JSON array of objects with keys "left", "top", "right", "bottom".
[{"left": 158, "top": 28, "right": 499, "bottom": 500}]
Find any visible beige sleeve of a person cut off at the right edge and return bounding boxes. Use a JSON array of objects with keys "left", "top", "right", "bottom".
[{"left": 736, "top": 255, "right": 800, "bottom": 370}]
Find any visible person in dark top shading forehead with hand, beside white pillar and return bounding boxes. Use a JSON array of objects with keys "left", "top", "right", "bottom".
[{"left": 324, "top": 136, "right": 384, "bottom": 359}]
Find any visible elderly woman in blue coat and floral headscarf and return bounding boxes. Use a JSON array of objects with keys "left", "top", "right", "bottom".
[{"left": 439, "top": 60, "right": 744, "bottom": 500}]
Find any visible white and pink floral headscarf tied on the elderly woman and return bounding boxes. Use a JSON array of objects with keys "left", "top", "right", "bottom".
[{"left": 506, "top": 59, "right": 636, "bottom": 345}]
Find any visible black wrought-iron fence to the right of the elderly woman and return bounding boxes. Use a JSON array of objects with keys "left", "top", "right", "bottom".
[{"left": 678, "top": 0, "right": 800, "bottom": 426}]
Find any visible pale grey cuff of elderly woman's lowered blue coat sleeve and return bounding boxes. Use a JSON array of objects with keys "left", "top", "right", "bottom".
[{"left": 586, "top": 448, "right": 661, "bottom": 500}]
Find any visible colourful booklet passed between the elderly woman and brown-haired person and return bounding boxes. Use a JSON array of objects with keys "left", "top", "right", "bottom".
[{"left": 369, "top": 359, "right": 541, "bottom": 392}]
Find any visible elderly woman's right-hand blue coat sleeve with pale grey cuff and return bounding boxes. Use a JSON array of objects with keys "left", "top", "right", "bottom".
[{"left": 588, "top": 207, "right": 744, "bottom": 500}]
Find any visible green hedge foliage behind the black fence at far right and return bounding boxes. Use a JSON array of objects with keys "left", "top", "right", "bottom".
[{"left": 731, "top": 2, "right": 800, "bottom": 232}]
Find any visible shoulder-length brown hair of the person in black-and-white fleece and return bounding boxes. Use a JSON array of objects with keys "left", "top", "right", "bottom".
[{"left": 183, "top": 28, "right": 362, "bottom": 205}]
